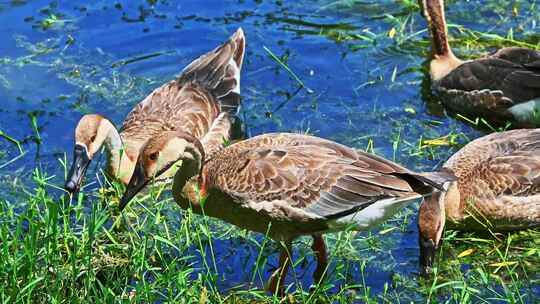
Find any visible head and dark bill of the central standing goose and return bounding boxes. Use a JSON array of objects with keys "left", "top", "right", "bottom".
[{"left": 119, "top": 131, "right": 204, "bottom": 210}]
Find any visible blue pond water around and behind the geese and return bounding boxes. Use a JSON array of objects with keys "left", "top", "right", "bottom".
[{"left": 0, "top": 0, "right": 540, "bottom": 300}]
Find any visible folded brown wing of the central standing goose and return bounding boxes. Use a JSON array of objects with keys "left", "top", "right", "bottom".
[{"left": 205, "top": 134, "right": 442, "bottom": 219}]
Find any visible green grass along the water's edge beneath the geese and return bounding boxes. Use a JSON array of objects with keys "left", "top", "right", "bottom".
[{"left": 0, "top": 156, "right": 540, "bottom": 303}]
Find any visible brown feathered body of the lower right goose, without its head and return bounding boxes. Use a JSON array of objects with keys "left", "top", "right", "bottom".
[{"left": 444, "top": 129, "right": 540, "bottom": 230}]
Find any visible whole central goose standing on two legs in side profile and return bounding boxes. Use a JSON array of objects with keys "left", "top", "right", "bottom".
[{"left": 120, "top": 132, "right": 452, "bottom": 293}]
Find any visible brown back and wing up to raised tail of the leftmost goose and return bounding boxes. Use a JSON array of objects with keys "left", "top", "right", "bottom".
[{"left": 122, "top": 29, "right": 245, "bottom": 141}]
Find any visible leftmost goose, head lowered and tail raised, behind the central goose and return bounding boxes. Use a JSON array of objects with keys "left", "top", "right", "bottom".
[{"left": 65, "top": 29, "right": 245, "bottom": 192}]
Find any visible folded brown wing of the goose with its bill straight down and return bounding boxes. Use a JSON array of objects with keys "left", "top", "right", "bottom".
[{"left": 445, "top": 129, "right": 540, "bottom": 200}]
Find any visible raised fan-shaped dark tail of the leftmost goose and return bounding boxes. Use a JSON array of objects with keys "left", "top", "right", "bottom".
[{"left": 178, "top": 28, "right": 246, "bottom": 115}]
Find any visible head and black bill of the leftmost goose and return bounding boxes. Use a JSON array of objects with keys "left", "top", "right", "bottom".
[{"left": 65, "top": 114, "right": 116, "bottom": 193}]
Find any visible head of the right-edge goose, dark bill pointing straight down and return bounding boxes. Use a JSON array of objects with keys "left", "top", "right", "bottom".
[{"left": 418, "top": 186, "right": 446, "bottom": 275}]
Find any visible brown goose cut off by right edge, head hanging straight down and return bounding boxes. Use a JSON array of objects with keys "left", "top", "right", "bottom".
[{"left": 418, "top": 129, "right": 540, "bottom": 273}]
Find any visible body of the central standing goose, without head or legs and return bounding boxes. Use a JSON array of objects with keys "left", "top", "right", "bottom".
[{"left": 181, "top": 133, "right": 431, "bottom": 241}]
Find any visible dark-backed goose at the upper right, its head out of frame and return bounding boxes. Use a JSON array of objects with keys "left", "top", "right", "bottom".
[{"left": 422, "top": 0, "right": 540, "bottom": 126}]
